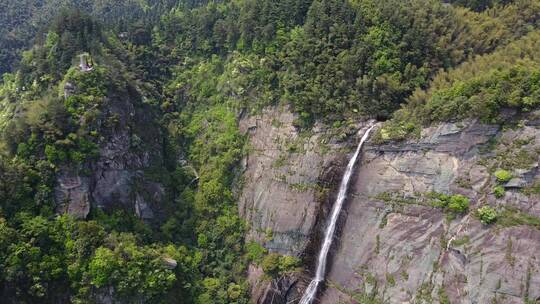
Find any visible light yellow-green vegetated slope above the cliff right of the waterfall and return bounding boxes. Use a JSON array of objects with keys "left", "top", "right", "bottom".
[{"left": 380, "top": 31, "right": 540, "bottom": 140}]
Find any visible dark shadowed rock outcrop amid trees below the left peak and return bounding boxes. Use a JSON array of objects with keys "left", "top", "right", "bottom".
[{"left": 55, "top": 83, "right": 164, "bottom": 220}]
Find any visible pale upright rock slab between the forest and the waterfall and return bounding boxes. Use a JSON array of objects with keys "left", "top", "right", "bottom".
[{"left": 239, "top": 110, "right": 336, "bottom": 254}]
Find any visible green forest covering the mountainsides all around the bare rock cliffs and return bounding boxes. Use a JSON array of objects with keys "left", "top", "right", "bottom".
[{"left": 0, "top": 0, "right": 540, "bottom": 304}]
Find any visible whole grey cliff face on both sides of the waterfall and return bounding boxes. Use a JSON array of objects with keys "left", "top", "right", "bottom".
[{"left": 240, "top": 113, "right": 540, "bottom": 303}]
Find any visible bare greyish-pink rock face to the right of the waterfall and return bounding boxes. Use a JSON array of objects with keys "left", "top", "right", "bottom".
[{"left": 320, "top": 121, "right": 540, "bottom": 303}]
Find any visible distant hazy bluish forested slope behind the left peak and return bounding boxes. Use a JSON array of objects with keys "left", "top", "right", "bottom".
[{"left": 0, "top": 0, "right": 186, "bottom": 74}]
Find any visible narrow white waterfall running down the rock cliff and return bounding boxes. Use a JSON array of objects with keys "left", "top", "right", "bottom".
[{"left": 300, "top": 126, "right": 374, "bottom": 304}]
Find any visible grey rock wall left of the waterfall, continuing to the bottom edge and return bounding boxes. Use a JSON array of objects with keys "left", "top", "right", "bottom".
[{"left": 239, "top": 108, "right": 370, "bottom": 303}]
